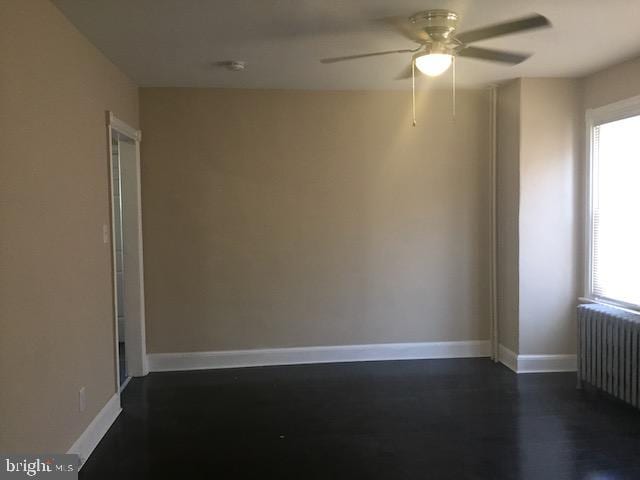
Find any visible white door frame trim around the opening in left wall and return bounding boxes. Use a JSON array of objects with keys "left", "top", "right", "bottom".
[{"left": 107, "top": 112, "right": 149, "bottom": 393}]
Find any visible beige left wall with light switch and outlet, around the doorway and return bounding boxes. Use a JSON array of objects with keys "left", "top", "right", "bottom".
[{"left": 0, "top": 0, "right": 138, "bottom": 453}]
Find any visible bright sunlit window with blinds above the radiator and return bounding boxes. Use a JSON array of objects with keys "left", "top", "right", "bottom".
[{"left": 587, "top": 99, "right": 640, "bottom": 307}]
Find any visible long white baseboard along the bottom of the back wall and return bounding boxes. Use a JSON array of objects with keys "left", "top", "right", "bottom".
[{"left": 148, "top": 340, "right": 490, "bottom": 372}]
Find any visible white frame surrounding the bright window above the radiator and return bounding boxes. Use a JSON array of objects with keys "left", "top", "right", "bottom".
[{"left": 583, "top": 95, "right": 640, "bottom": 312}]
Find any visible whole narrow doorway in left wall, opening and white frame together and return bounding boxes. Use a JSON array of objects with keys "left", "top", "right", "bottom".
[{"left": 108, "top": 113, "right": 149, "bottom": 391}]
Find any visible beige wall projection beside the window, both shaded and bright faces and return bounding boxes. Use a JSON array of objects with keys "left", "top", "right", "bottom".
[{"left": 497, "top": 78, "right": 582, "bottom": 355}]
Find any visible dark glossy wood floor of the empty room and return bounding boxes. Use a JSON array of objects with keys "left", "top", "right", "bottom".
[{"left": 80, "top": 359, "right": 640, "bottom": 480}]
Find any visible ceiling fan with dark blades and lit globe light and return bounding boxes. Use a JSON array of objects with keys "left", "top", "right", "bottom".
[{"left": 320, "top": 10, "right": 551, "bottom": 125}]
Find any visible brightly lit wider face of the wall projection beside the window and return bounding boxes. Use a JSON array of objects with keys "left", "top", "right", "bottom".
[{"left": 518, "top": 78, "right": 582, "bottom": 355}]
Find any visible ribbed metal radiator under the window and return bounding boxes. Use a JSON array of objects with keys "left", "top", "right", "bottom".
[{"left": 578, "top": 304, "right": 640, "bottom": 407}]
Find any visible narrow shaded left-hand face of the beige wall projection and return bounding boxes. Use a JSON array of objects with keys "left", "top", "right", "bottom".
[{"left": 496, "top": 80, "right": 520, "bottom": 352}]
